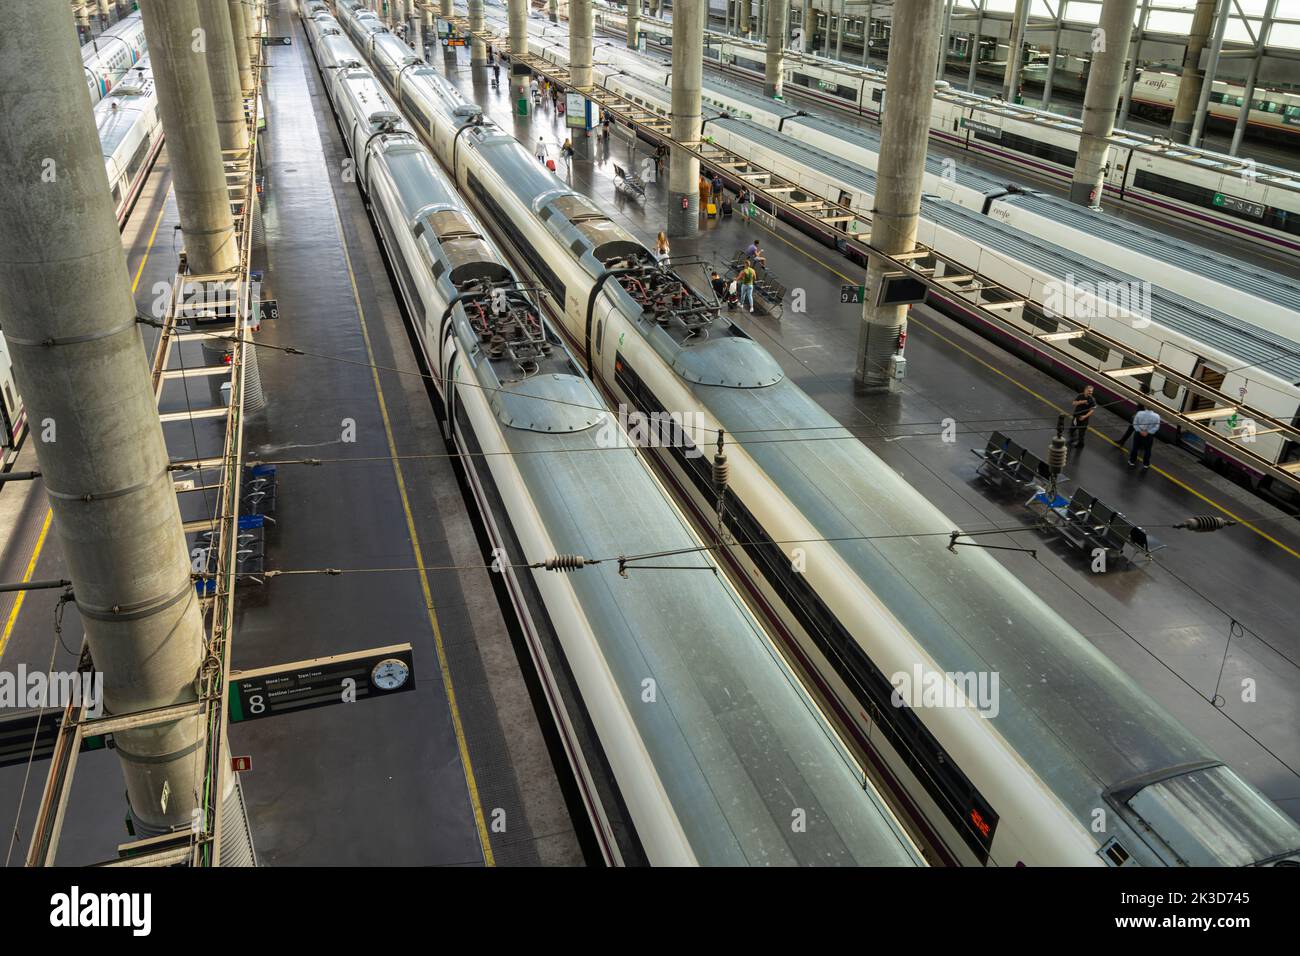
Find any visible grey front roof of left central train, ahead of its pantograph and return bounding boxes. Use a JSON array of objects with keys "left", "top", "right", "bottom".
[{"left": 506, "top": 413, "right": 919, "bottom": 865}]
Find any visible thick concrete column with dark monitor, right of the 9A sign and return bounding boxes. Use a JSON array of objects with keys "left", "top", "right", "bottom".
[{"left": 854, "top": 0, "right": 944, "bottom": 390}]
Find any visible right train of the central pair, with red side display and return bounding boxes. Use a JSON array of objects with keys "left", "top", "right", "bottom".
[{"left": 335, "top": 0, "right": 1300, "bottom": 866}]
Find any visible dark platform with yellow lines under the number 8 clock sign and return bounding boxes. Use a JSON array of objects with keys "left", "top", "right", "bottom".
[{"left": 0, "top": 5, "right": 585, "bottom": 866}]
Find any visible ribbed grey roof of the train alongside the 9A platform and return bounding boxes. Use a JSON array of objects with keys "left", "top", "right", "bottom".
[{"left": 716, "top": 120, "right": 1300, "bottom": 384}]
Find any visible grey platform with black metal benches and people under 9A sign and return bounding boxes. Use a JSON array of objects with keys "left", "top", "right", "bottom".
[{"left": 428, "top": 46, "right": 1300, "bottom": 819}]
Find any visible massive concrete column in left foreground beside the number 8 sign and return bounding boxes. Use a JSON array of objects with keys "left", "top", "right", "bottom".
[{"left": 0, "top": 0, "right": 216, "bottom": 836}]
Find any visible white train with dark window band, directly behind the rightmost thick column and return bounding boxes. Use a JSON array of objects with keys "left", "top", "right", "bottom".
[{"left": 595, "top": 4, "right": 1300, "bottom": 265}]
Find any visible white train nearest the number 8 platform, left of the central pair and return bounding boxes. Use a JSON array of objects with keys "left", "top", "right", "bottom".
[{"left": 300, "top": 3, "right": 923, "bottom": 865}]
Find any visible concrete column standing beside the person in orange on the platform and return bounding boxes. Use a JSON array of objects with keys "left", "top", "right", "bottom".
[{"left": 667, "top": 0, "right": 709, "bottom": 237}]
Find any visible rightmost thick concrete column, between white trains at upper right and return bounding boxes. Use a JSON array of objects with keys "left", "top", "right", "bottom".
[{"left": 1070, "top": 0, "right": 1138, "bottom": 206}]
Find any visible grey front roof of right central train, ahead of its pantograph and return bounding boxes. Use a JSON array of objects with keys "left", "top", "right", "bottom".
[{"left": 694, "top": 369, "right": 1300, "bottom": 864}]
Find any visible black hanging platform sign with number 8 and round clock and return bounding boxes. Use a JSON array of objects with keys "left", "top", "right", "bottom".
[{"left": 229, "top": 644, "right": 415, "bottom": 723}]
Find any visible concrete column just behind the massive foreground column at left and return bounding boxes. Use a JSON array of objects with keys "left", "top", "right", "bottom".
[{"left": 139, "top": 0, "right": 239, "bottom": 274}]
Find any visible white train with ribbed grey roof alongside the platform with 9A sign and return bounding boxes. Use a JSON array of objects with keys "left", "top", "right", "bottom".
[{"left": 491, "top": 14, "right": 1300, "bottom": 499}]
